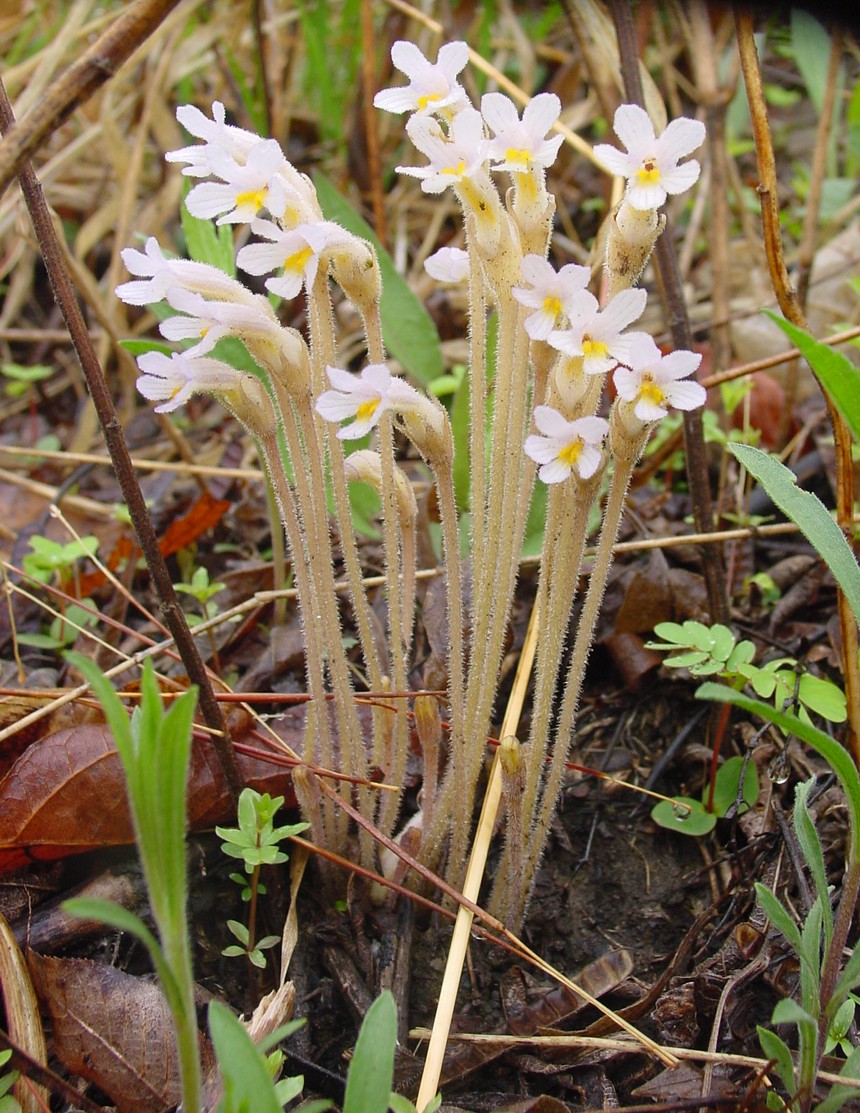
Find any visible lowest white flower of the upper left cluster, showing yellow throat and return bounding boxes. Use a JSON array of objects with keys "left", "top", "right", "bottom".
[{"left": 236, "top": 220, "right": 349, "bottom": 297}]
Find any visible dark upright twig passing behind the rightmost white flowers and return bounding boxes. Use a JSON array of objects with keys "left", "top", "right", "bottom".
[{"left": 609, "top": 0, "right": 729, "bottom": 622}]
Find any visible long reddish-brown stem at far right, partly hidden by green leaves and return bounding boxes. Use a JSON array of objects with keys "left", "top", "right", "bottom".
[{"left": 734, "top": 15, "right": 860, "bottom": 766}]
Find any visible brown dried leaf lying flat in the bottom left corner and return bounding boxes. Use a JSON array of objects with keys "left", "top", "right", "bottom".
[{"left": 29, "top": 952, "right": 214, "bottom": 1113}]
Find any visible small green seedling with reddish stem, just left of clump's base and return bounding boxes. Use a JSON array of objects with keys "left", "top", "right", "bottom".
[{"left": 215, "top": 788, "right": 308, "bottom": 968}]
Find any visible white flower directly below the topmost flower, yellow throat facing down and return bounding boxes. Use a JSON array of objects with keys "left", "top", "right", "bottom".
[{"left": 397, "top": 108, "right": 487, "bottom": 194}]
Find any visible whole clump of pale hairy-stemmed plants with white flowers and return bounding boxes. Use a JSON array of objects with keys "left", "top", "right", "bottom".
[{"left": 117, "top": 42, "right": 705, "bottom": 926}]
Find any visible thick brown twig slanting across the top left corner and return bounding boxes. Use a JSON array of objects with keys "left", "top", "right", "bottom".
[{"left": 0, "top": 0, "right": 179, "bottom": 195}]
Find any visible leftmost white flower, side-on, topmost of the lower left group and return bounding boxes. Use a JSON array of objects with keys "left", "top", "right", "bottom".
[{"left": 116, "top": 236, "right": 260, "bottom": 305}]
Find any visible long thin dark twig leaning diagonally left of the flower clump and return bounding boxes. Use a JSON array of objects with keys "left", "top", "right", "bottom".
[{"left": 0, "top": 80, "right": 243, "bottom": 801}]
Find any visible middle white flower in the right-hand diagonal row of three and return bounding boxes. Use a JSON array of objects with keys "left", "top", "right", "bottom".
[{"left": 548, "top": 288, "right": 648, "bottom": 375}]
